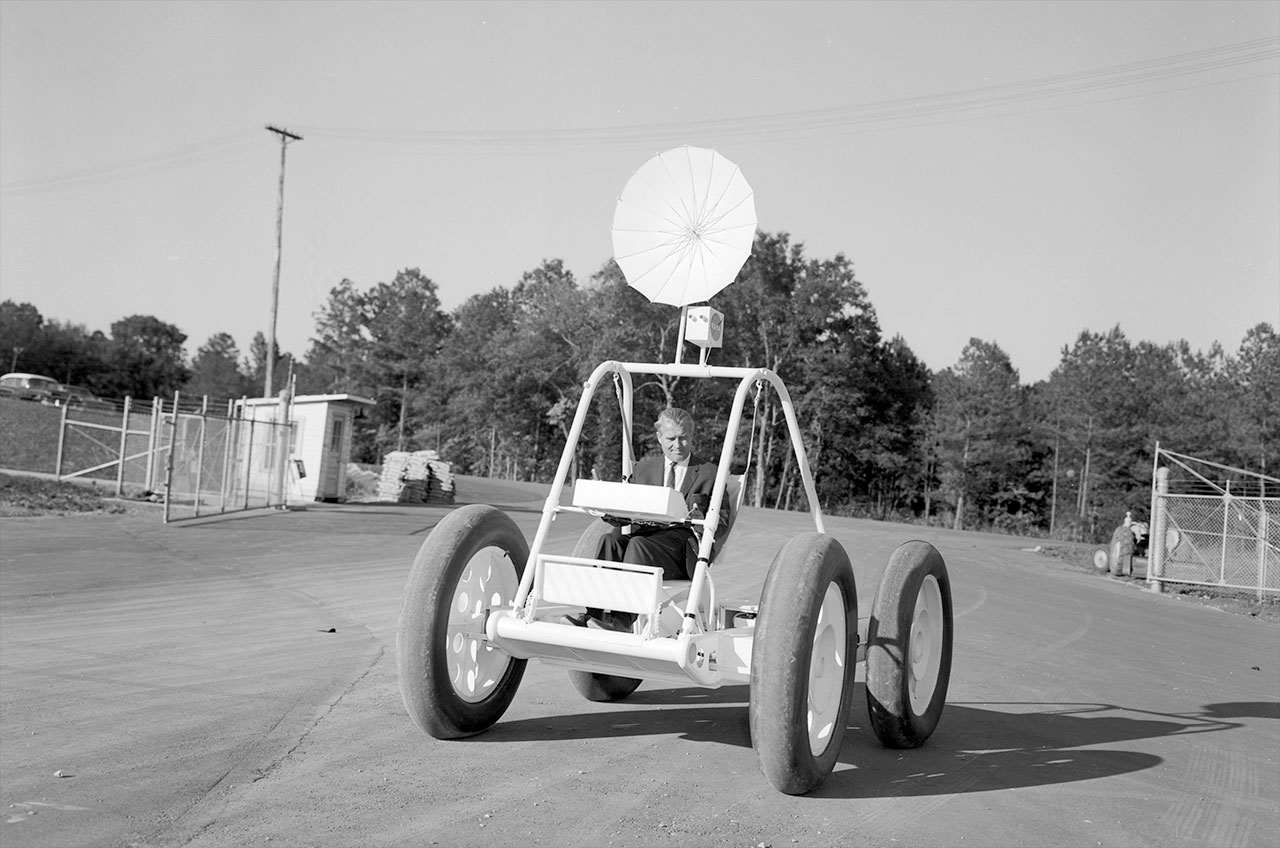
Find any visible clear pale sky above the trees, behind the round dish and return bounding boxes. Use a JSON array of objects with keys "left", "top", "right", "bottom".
[{"left": 0, "top": 0, "right": 1280, "bottom": 383}]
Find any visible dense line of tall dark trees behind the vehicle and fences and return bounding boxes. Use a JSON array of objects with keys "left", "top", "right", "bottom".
[{"left": 0, "top": 232, "right": 1280, "bottom": 541}]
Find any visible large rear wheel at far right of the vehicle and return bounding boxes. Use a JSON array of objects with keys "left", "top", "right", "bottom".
[{"left": 867, "top": 542, "right": 955, "bottom": 748}]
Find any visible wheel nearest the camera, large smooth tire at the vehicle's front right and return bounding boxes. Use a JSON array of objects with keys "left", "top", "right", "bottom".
[{"left": 748, "top": 533, "right": 858, "bottom": 795}]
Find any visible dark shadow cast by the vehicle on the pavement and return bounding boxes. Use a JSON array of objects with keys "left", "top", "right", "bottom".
[{"left": 476, "top": 684, "right": 1264, "bottom": 798}]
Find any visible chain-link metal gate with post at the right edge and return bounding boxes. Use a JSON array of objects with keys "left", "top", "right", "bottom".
[{"left": 1147, "top": 444, "right": 1280, "bottom": 597}]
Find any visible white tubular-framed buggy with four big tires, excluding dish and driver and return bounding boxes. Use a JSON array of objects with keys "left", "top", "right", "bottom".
[{"left": 397, "top": 149, "right": 952, "bottom": 794}]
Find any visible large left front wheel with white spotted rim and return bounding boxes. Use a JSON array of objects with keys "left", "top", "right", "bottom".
[{"left": 396, "top": 503, "right": 529, "bottom": 739}]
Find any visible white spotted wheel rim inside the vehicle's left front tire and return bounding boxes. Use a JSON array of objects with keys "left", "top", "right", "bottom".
[{"left": 447, "top": 547, "right": 520, "bottom": 703}]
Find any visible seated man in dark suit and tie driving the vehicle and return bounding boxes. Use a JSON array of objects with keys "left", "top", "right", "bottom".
[{"left": 564, "top": 407, "right": 730, "bottom": 630}]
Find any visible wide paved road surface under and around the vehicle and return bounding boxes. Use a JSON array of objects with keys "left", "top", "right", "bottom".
[{"left": 0, "top": 482, "right": 1280, "bottom": 848}]
